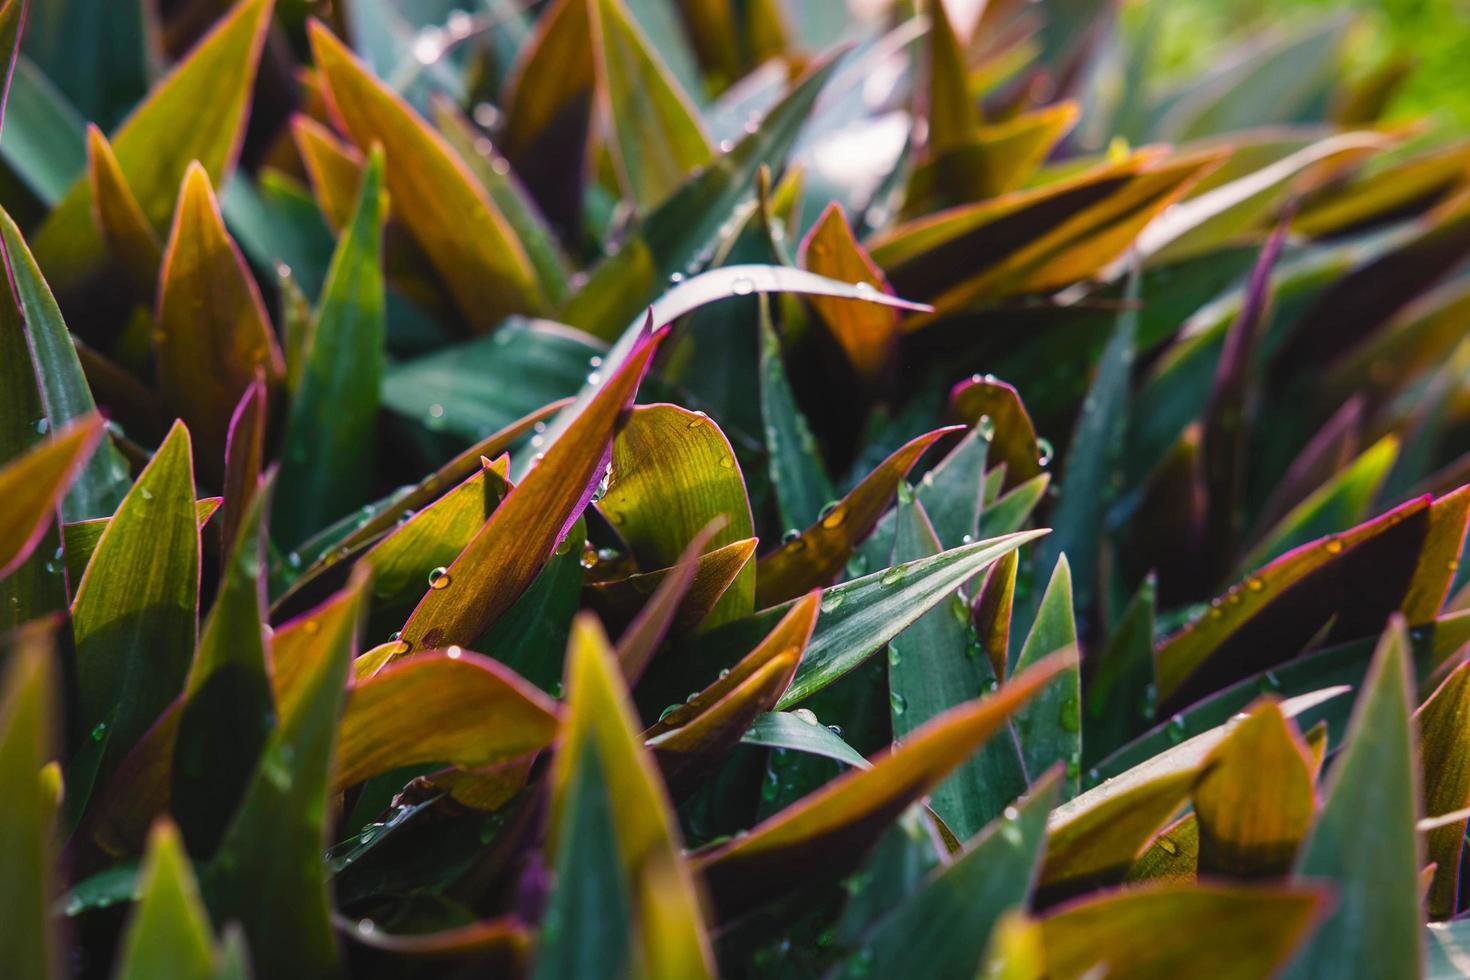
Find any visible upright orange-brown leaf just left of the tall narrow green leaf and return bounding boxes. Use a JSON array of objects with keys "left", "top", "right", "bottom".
[{"left": 154, "top": 166, "right": 285, "bottom": 479}]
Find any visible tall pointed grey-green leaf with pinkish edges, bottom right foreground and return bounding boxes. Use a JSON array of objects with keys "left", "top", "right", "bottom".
[{"left": 1286, "top": 617, "right": 1424, "bottom": 977}]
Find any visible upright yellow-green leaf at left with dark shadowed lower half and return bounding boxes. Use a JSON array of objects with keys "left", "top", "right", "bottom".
[{"left": 66, "top": 422, "right": 200, "bottom": 817}]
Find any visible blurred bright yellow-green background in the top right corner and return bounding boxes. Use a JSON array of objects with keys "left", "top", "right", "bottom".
[{"left": 1125, "top": 0, "right": 1470, "bottom": 132}]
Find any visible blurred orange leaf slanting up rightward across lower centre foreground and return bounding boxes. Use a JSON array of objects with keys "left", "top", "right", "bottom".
[{"left": 697, "top": 655, "right": 1069, "bottom": 915}]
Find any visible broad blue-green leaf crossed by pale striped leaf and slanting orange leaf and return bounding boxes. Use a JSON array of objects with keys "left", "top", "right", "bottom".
[{"left": 888, "top": 485, "right": 1026, "bottom": 840}]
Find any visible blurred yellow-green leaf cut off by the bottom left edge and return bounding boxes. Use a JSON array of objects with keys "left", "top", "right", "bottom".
[{"left": 0, "top": 626, "right": 62, "bottom": 979}]
